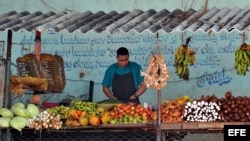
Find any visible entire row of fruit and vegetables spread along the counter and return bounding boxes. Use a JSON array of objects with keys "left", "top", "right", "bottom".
[{"left": 0, "top": 91, "right": 250, "bottom": 131}]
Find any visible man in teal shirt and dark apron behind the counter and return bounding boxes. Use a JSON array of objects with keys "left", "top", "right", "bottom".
[{"left": 102, "top": 47, "right": 147, "bottom": 104}]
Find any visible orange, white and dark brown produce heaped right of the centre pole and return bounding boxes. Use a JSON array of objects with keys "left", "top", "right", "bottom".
[{"left": 161, "top": 91, "right": 250, "bottom": 123}]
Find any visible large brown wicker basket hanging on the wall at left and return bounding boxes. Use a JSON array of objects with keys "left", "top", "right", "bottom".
[{"left": 16, "top": 54, "right": 66, "bottom": 93}]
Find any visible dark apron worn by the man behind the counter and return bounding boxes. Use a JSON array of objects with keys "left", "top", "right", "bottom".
[{"left": 112, "top": 66, "right": 140, "bottom": 104}]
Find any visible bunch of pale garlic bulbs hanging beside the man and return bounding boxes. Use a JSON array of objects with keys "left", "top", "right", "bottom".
[{"left": 141, "top": 54, "right": 169, "bottom": 90}]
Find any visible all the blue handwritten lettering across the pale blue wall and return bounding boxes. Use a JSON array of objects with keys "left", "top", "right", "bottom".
[{"left": 17, "top": 32, "right": 238, "bottom": 87}]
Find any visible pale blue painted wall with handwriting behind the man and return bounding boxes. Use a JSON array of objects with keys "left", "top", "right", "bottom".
[{"left": 0, "top": 30, "right": 250, "bottom": 104}]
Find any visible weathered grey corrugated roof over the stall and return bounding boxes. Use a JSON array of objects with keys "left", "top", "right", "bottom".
[{"left": 0, "top": 7, "right": 250, "bottom": 33}]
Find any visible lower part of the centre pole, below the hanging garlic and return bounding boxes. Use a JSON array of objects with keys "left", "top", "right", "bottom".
[{"left": 156, "top": 90, "right": 161, "bottom": 141}]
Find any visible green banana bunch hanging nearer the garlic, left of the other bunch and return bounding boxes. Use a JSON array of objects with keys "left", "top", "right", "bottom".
[{"left": 174, "top": 37, "right": 196, "bottom": 80}]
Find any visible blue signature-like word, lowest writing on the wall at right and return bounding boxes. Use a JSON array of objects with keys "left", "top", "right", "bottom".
[{"left": 196, "top": 68, "right": 232, "bottom": 88}]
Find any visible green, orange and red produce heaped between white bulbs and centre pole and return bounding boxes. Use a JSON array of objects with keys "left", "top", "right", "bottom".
[{"left": 46, "top": 99, "right": 156, "bottom": 127}]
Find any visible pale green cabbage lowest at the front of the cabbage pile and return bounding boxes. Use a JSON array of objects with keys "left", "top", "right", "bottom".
[{"left": 10, "top": 116, "right": 27, "bottom": 131}]
